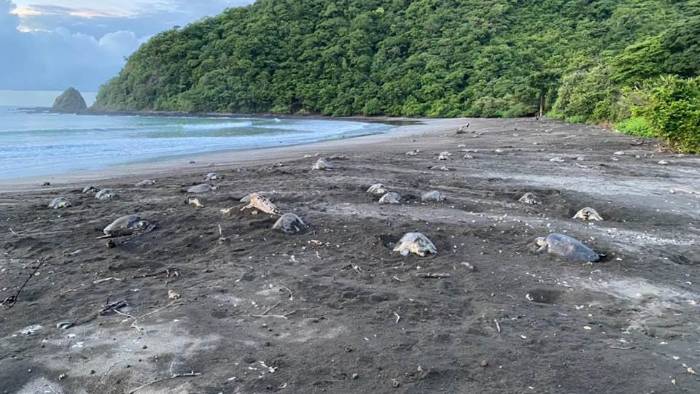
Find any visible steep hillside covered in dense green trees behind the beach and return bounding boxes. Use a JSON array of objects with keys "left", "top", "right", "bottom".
[{"left": 95, "top": 0, "right": 700, "bottom": 150}]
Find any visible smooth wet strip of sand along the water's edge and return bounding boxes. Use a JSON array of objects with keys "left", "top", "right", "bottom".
[{"left": 0, "top": 114, "right": 470, "bottom": 194}]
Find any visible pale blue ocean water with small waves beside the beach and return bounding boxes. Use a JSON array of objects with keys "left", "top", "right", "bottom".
[{"left": 0, "top": 106, "right": 392, "bottom": 180}]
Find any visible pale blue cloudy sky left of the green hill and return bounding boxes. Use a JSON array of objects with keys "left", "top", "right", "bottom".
[{"left": 0, "top": 0, "right": 253, "bottom": 91}]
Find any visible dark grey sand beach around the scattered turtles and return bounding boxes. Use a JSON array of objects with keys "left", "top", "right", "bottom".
[{"left": 0, "top": 119, "right": 700, "bottom": 393}]
